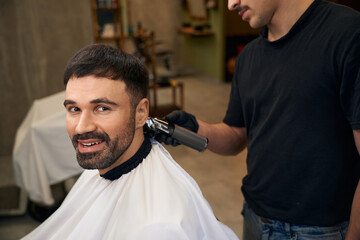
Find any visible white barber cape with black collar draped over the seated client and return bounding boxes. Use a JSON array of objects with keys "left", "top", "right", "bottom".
[{"left": 23, "top": 139, "right": 238, "bottom": 240}]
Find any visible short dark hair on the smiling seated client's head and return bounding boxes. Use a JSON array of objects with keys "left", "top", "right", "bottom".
[{"left": 64, "top": 44, "right": 149, "bottom": 107}]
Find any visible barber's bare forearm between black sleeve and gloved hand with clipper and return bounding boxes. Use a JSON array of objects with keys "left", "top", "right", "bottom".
[{"left": 197, "top": 120, "right": 247, "bottom": 155}]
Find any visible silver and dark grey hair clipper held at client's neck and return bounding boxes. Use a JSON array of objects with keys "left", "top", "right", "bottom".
[{"left": 145, "top": 117, "right": 208, "bottom": 152}]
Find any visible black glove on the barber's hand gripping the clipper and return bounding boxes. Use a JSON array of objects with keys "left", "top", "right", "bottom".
[{"left": 155, "top": 110, "right": 199, "bottom": 147}]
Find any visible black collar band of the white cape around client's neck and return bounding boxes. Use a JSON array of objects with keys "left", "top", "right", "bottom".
[{"left": 100, "top": 137, "right": 151, "bottom": 181}]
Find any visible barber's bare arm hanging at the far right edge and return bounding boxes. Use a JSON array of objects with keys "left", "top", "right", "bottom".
[{"left": 345, "top": 130, "right": 360, "bottom": 240}]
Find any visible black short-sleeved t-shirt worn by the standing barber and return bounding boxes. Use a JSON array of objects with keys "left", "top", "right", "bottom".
[{"left": 224, "top": 0, "right": 360, "bottom": 226}]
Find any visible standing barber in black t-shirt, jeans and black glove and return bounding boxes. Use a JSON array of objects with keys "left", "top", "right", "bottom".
[{"left": 159, "top": 0, "right": 360, "bottom": 240}]
